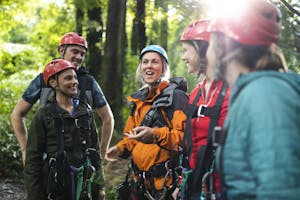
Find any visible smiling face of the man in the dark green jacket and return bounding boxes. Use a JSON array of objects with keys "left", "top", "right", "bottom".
[{"left": 50, "top": 69, "right": 78, "bottom": 97}]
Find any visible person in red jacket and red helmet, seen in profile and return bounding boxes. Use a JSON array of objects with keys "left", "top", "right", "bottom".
[{"left": 180, "top": 20, "right": 229, "bottom": 200}]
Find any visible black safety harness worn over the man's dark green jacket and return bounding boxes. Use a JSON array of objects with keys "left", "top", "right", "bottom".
[{"left": 47, "top": 102, "right": 98, "bottom": 200}]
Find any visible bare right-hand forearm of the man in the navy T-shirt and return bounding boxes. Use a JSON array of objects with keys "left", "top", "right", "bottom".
[{"left": 96, "top": 104, "right": 115, "bottom": 158}]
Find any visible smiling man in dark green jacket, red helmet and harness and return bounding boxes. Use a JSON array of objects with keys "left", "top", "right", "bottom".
[{"left": 24, "top": 59, "right": 102, "bottom": 200}]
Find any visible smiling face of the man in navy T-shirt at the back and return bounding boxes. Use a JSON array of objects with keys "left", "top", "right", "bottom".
[{"left": 59, "top": 45, "right": 86, "bottom": 68}]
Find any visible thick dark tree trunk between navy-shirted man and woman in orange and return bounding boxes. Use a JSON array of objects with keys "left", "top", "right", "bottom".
[{"left": 99, "top": 0, "right": 126, "bottom": 132}]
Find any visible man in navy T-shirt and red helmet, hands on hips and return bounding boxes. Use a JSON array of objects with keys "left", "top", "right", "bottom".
[{"left": 11, "top": 32, "right": 114, "bottom": 198}]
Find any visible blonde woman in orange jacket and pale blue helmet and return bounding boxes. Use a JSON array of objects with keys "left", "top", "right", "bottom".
[{"left": 107, "top": 45, "right": 188, "bottom": 199}]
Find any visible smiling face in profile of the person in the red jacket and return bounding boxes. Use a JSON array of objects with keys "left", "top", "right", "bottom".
[{"left": 181, "top": 42, "right": 200, "bottom": 75}]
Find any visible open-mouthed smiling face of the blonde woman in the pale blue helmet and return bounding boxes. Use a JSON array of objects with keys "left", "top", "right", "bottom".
[{"left": 140, "top": 52, "right": 163, "bottom": 85}]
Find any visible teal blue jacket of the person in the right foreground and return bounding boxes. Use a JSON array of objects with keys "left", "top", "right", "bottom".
[{"left": 217, "top": 71, "right": 300, "bottom": 200}]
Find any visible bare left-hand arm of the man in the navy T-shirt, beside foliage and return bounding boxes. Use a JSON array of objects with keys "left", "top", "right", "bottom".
[{"left": 11, "top": 99, "right": 32, "bottom": 164}]
